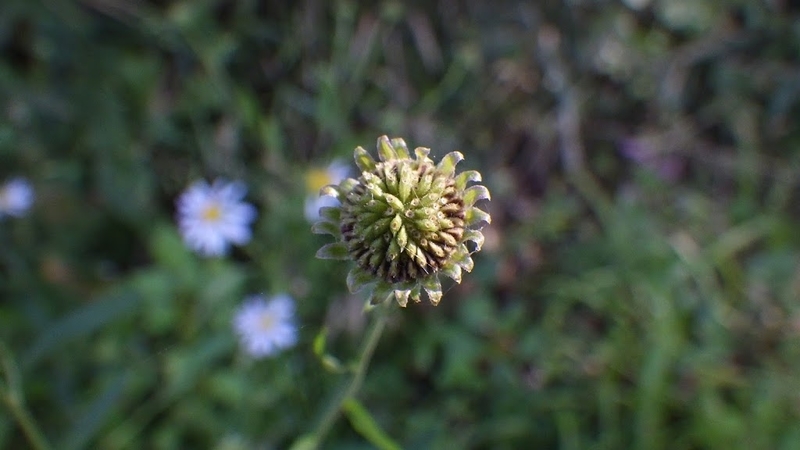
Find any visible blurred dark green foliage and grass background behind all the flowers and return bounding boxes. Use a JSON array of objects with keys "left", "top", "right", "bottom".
[{"left": 0, "top": 0, "right": 800, "bottom": 450}]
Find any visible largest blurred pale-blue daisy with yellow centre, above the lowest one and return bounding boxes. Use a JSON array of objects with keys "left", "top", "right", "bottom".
[{"left": 176, "top": 180, "right": 256, "bottom": 256}]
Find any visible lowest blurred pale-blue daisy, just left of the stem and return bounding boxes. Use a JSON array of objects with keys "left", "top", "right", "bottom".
[{"left": 233, "top": 294, "right": 297, "bottom": 358}]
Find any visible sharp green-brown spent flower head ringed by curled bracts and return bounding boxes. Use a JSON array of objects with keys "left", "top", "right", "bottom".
[{"left": 312, "top": 136, "right": 491, "bottom": 306}]
